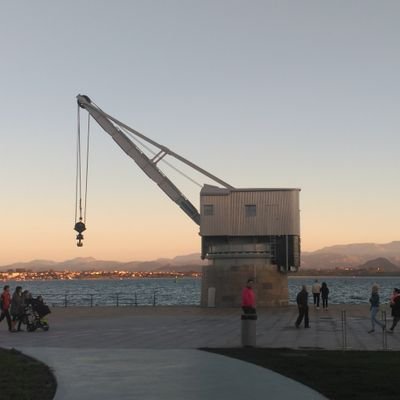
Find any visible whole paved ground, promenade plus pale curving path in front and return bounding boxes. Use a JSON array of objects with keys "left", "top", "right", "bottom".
[{"left": 0, "top": 306, "right": 400, "bottom": 400}]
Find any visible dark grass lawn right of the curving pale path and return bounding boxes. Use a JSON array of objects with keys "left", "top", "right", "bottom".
[{"left": 202, "top": 348, "right": 400, "bottom": 400}]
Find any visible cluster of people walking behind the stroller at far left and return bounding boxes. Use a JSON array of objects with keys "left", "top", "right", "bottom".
[{"left": 0, "top": 285, "right": 32, "bottom": 332}]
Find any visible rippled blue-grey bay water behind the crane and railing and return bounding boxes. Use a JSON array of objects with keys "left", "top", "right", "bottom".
[{"left": 0, "top": 277, "right": 400, "bottom": 306}]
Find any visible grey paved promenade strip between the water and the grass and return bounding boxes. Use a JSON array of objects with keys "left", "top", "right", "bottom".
[{"left": 0, "top": 305, "right": 400, "bottom": 350}]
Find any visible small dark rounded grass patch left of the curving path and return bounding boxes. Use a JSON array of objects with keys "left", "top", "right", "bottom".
[{"left": 0, "top": 348, "right": 57, "bottom": 400}]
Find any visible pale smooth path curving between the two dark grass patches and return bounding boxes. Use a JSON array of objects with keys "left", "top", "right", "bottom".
[{"left": 20, "top": 347, "right": 324, "bottom": 400}]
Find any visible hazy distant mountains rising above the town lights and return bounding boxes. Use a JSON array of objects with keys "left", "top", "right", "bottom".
[{"left": 0, "top": 241, "right": 400, "bottom": 272}]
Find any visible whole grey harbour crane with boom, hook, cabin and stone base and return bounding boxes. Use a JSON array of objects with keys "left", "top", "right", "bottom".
[{"left": 75, "top": 95, "right": 300, "bottom": 307}]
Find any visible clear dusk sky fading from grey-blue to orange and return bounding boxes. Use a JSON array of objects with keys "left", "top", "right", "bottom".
[{"left": 0, "top": 0, "right": 400, "bottom": 265}]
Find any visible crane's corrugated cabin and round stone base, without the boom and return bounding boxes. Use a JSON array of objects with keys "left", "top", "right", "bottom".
[{"left": 200, "top": 185, "right": 300, "bottom": 306}]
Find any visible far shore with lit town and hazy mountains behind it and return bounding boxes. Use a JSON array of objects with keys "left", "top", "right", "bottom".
[{"left": 0, "top": 241, "right": 400, "bottom": 280}]
